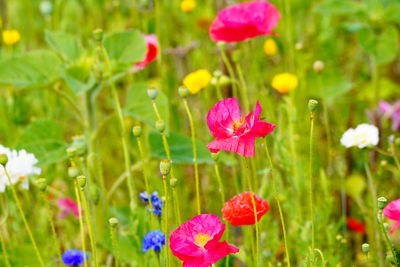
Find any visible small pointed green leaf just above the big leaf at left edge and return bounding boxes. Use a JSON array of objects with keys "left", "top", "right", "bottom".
[{"left": 45, "top": 31, "right": 81, "bottom": 60}]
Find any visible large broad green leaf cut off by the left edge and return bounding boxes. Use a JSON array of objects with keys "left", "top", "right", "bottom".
[{"left": 0, "top": 50, "right": 62, "bottom": 88}]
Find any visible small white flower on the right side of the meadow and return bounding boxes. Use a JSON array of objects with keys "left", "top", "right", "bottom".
[{"left": 340, "top": 123, "right": 379, "bottom": 148}]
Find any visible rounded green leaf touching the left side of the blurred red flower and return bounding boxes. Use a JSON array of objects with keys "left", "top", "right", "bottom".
[{"left": 103, "top": 30, "right": 147, "bottom": 63}]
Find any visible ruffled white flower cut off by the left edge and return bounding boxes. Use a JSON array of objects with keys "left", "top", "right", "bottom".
[{"left": 0, "top": 145, "right": 41, "bottom": 192}]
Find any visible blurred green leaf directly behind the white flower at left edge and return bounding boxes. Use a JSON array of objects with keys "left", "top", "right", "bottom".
[{"left": 17, "top": 120, "right": 68, "bottom": 166}]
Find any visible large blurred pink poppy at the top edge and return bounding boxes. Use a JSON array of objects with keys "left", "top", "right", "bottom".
[{"left": 209, "top": 1, "right": 281, "bottom": 42}]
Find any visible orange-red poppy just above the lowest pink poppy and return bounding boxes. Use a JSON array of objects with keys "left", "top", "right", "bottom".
[{"left": 222, "top": 192, "right": 269, "bottom": 225}]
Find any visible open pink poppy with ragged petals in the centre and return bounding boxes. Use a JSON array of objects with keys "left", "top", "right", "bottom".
[{"left": 207, "top": 97, "right": 275, "bottom": 157}]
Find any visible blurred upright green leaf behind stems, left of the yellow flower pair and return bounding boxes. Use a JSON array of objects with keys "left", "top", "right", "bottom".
[{"left": 124, "top": 83, "right": 169, "bottom": 128}]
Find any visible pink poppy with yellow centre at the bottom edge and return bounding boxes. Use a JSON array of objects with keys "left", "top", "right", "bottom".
[{"left": 170, "top": 214, "right": 239, "bottom": 267}]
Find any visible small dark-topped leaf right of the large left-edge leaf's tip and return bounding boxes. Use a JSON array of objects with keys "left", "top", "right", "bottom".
[{"left": 63, "top": 66, "right": 96, "bottom": 95}]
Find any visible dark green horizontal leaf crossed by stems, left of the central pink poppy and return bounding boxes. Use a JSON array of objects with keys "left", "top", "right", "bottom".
[{"left": 149, "top": 132, "right": 235, "bottom": 165}]
